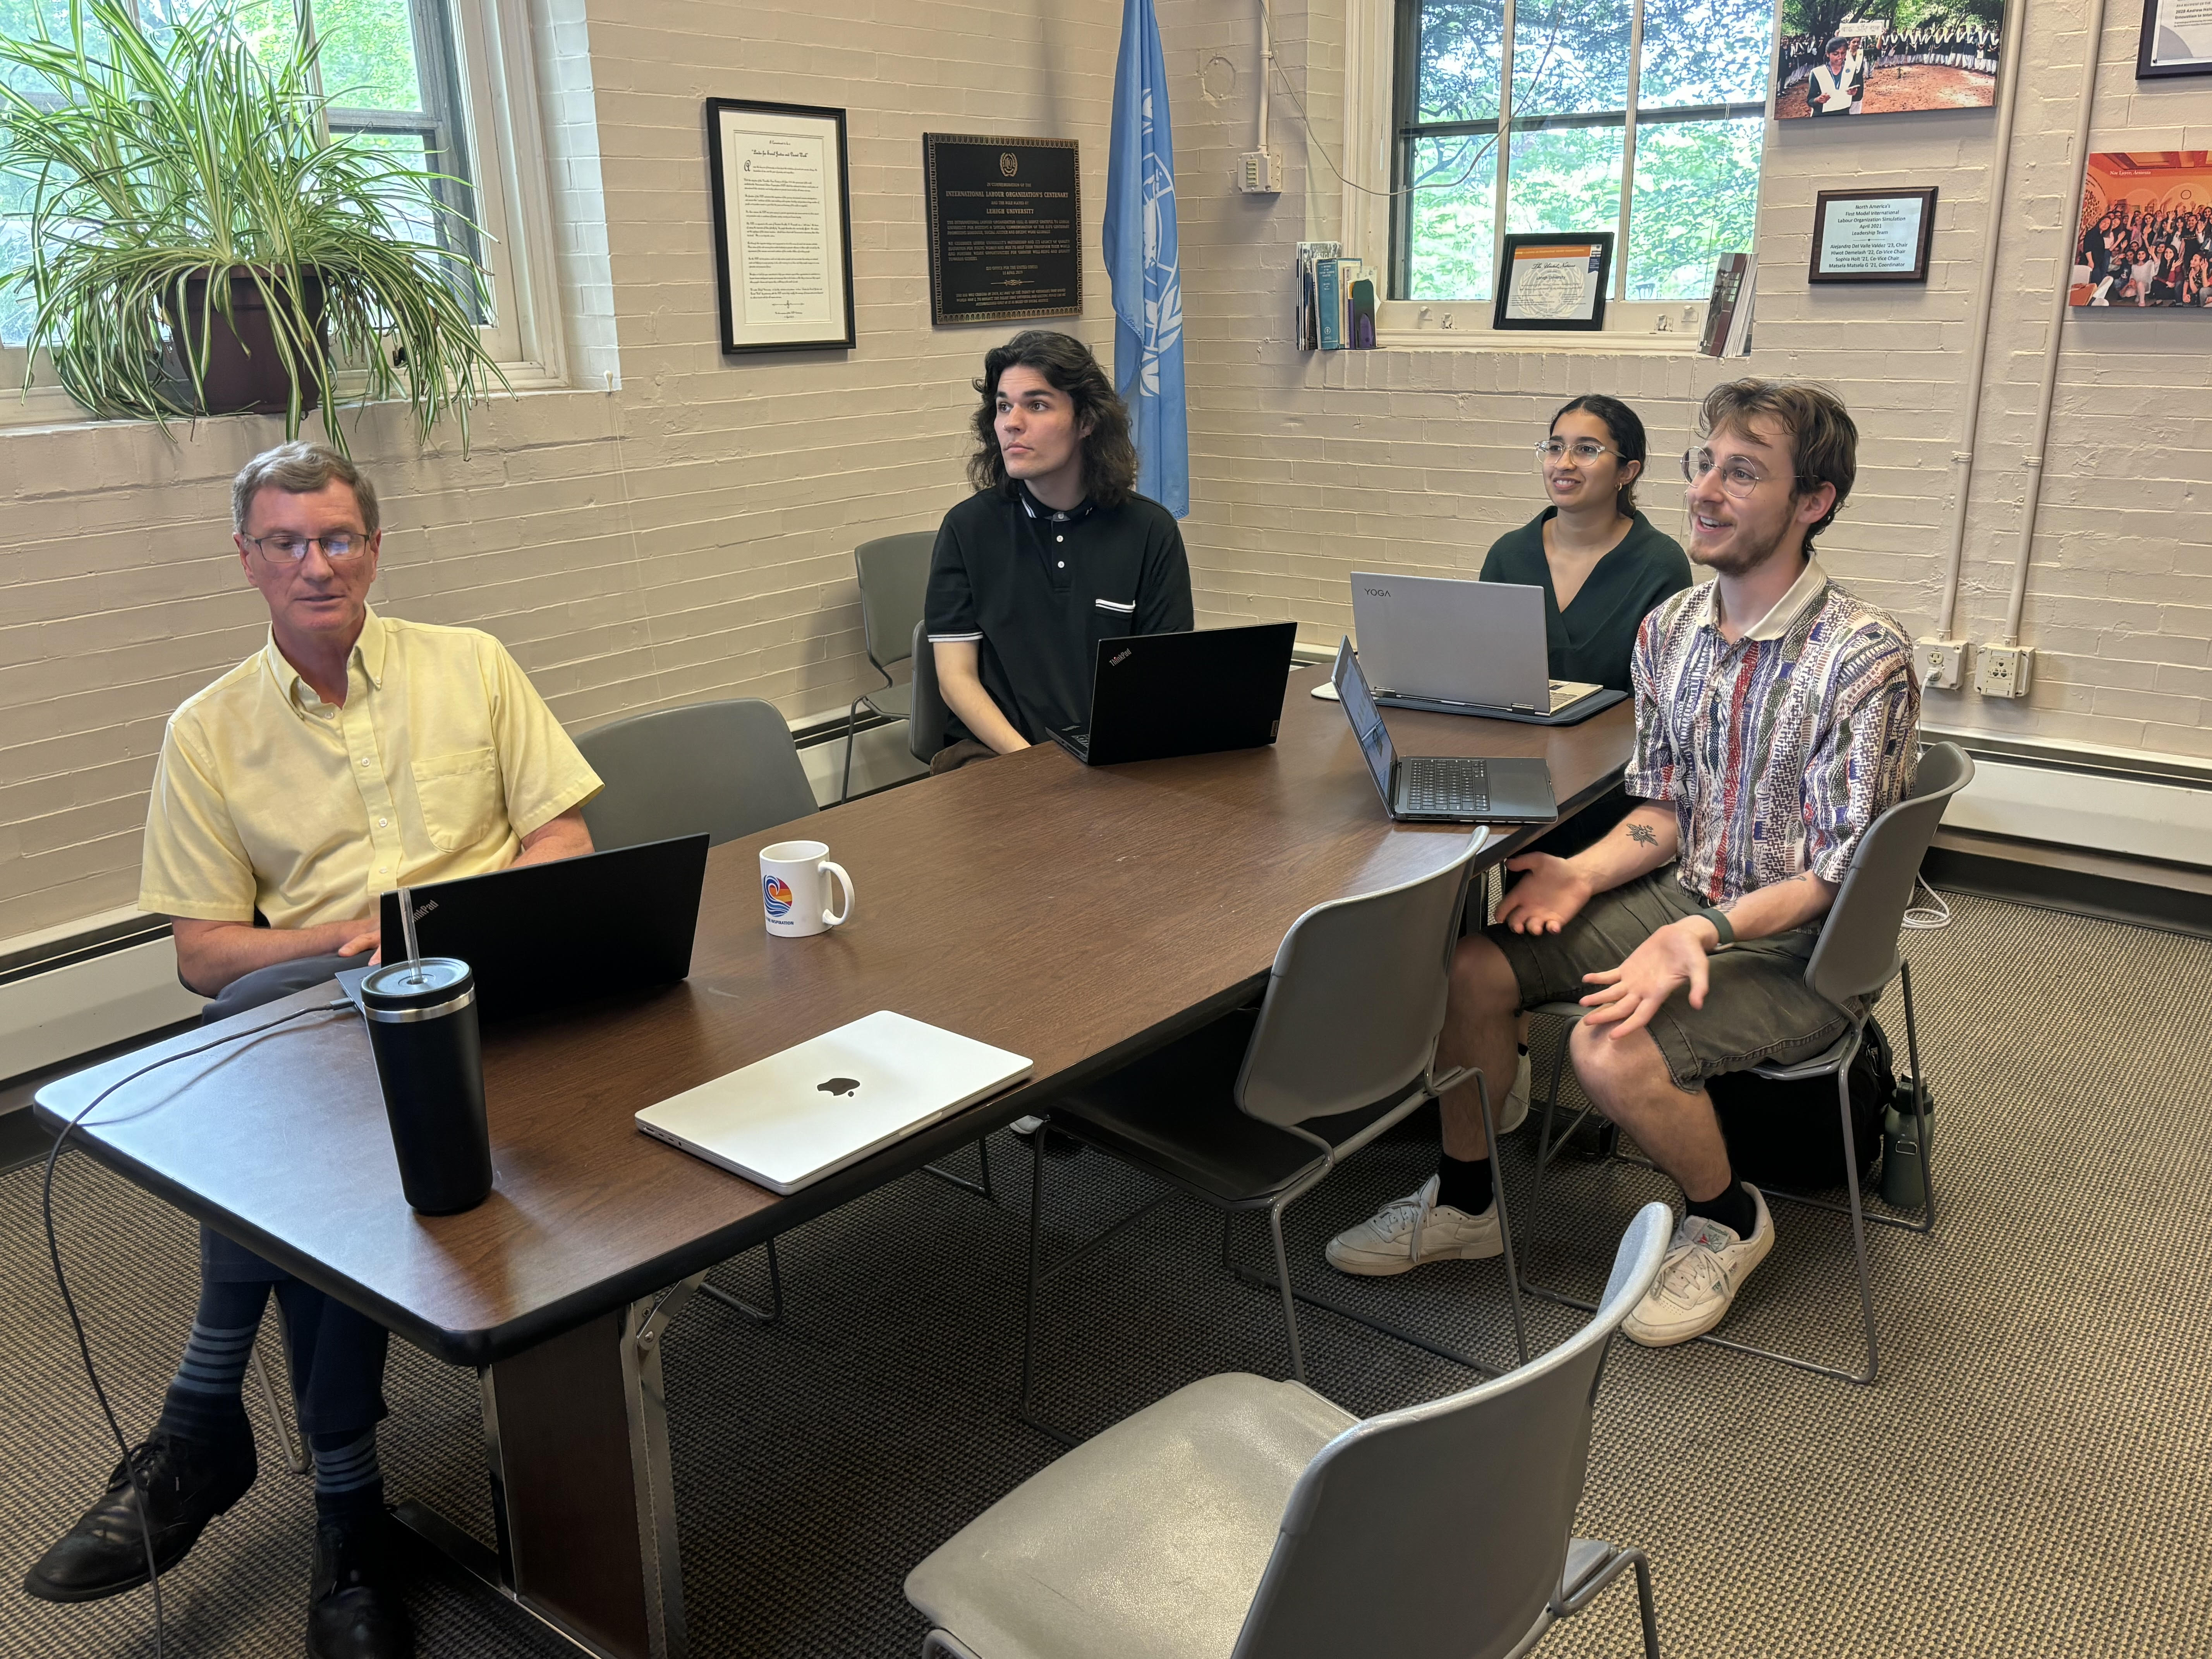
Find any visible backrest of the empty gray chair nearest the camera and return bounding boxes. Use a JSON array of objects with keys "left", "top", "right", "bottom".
[{"left": 1232, "top": 1203, "right": 1674, "bottom": 1659}]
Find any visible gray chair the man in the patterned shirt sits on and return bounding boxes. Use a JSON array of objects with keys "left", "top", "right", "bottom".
[{"left": 1528, "top": 743, "right": 1973, "bottom": 1382}]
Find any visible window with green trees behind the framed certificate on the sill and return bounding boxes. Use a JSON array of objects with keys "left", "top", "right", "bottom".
[{"left": 1391, "top": 0, "right": 1774, "bottom": 301}]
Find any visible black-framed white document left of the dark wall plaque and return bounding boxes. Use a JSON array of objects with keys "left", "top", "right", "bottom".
[{"left": 706, "top": 97, "right": 854, "bottom": 352}]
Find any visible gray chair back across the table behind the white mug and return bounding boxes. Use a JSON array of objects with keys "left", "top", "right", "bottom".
[{"left": 575, "top": 697, "right": 816, "bottom": 852}]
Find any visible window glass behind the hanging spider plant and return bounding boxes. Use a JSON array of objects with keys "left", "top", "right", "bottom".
[{"left": 0, "top": 0, "right": 491, "bottom": 345}]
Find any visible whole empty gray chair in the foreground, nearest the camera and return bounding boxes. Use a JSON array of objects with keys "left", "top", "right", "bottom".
[{"left": 907, "top": 1203, "right": 1672, "bottom": 1659}]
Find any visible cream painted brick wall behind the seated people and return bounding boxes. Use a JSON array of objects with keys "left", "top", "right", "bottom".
[{"left": 0, "top": 0, "right": 2212, "bottom": 938}]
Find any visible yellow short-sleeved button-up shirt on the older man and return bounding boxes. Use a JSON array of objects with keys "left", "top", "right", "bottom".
[{"left": 139, "top": 611, "right": 599, "bottom": 927}]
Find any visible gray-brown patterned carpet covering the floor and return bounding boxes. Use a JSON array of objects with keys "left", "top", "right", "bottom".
[{"left": 0, "top": 898, "right": 2212, "bottom": 1659}]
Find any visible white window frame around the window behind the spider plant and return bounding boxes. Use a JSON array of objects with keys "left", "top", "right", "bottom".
[{"left": 0, "top": 0, "right": 568, "bottom": 429}]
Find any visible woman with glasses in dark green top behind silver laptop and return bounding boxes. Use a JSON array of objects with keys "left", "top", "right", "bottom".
[{"left": 1482, "top": 394, "right": 1690, "bottom": 690}]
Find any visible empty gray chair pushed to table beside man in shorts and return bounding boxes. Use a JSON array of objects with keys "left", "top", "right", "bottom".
[{"left": 1020, "top": 830, "right": 1528, "bottom": 1440}]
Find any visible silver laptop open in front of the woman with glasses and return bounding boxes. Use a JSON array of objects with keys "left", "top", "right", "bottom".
[{"left": 1352, "top": 571, "right": 1619, "bottom": 723}]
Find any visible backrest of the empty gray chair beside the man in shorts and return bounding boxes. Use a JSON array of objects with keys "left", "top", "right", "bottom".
[{"left": 1237, "top": 830, "right": 1486, "bottom": 1124}]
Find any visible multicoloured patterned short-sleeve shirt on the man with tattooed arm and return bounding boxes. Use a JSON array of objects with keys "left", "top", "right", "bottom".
[{"left": 1626, "top": 560, "right": 1920, "bottom": 905}]
